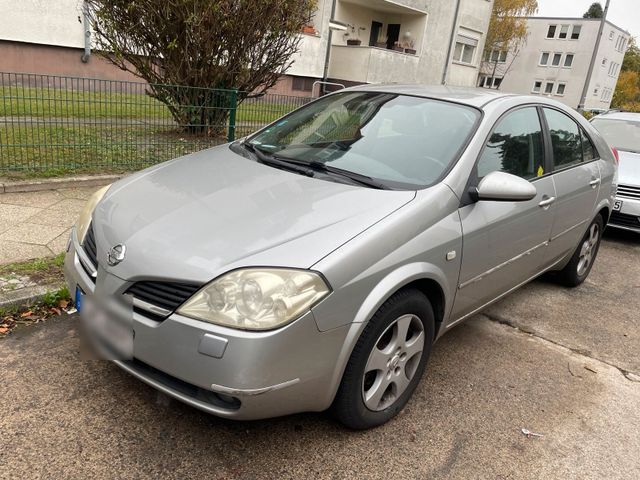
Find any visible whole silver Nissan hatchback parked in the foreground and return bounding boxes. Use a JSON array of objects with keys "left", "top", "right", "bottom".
[{"left": 65, "top": 85, "right": 616, "bottom": 429}]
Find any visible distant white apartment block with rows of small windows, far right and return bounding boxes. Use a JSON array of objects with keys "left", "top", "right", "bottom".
[{"left": 478, "top": 17, "right": 630, "bottom": 110}]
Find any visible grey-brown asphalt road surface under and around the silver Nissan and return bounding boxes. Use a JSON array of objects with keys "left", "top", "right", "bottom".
[{"left": 0, "top": 229, "right": 640, "bottom": 479}]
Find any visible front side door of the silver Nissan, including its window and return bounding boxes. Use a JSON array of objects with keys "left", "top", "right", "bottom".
[{"left": 452, "top": 107, "right": 556, "bottom": 321}]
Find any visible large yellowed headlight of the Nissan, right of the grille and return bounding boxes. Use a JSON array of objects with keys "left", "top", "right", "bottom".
[{"left": 178, "top": 268, "right": 329, "bottom": 330}]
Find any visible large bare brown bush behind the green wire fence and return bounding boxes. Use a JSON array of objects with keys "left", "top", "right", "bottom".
[{"left": 87, "top": 0, "right": 316, "bottom": 132}]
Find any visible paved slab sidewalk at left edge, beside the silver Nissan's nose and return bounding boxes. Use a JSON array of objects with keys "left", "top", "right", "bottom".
[{"left": 0, "top": 186, "right": 100, "bottom": 265}]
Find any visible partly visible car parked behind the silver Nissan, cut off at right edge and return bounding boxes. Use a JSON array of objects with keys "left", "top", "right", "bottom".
[{"left": 591, "top": 112, "right": 640, "bottom": 233}]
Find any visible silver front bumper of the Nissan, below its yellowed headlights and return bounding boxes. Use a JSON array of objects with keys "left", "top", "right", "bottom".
[{"left": 64, "top": 231, "right": 349, "bottom": 420}]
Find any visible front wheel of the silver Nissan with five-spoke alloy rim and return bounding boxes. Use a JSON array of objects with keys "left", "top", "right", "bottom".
[{"left": 333, "top": 289, "right": 435, "bottom": 430}]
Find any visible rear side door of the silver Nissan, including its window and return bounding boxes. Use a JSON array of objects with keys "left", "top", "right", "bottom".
[{"left": 542, "top": 107, "right": 601, "bottom": 260}]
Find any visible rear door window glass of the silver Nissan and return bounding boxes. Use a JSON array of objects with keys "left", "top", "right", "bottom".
[{"left": 544, "top": 108, "right": 582, "bottom": 170}]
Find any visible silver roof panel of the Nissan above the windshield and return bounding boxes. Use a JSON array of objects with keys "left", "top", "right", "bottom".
[{"left": 336, "top": 84, "right": 516, "bottom": 108}]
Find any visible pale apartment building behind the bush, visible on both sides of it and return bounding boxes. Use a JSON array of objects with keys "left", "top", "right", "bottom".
[{"left": 0, "top": 0, "right": 493, "bottom": 95}]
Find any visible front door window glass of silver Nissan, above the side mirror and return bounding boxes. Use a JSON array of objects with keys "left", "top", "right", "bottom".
[{"left": 478, "top": 107, "right": 544, "bottom": 180}]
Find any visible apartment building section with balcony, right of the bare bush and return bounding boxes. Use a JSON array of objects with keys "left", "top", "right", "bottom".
[{"left": 281, "top": 0, "right": 493, "bottom": 93}]
